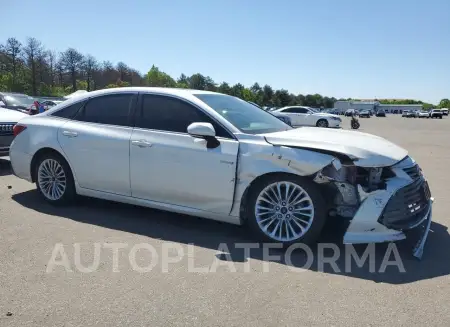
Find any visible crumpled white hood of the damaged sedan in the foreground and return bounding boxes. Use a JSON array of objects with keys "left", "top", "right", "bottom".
[{"left": 263, "top": 127, "right": 408, "bottom": 167}]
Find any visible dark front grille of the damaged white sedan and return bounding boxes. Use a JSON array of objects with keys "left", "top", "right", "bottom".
[{"left": 378, "top": 177, "right": 431, "bottom": 230}]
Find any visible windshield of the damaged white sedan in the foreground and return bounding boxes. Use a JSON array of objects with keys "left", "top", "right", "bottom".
[{"left": 194, "top": 94, "right": 292, "bottom": 134}]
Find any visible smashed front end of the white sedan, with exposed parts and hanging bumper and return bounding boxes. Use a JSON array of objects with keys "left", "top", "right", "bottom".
[{"left": 314, "top": 156, "right": 433, "bottom": 259}]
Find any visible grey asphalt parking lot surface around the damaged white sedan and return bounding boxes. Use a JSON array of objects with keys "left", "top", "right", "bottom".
[{"left": 0, "top": 115, "right": 450, "bottom": 326}]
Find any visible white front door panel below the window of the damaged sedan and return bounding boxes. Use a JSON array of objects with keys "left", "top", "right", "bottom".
[{"left": 130, "top": 128, "right": 239, "bottom": 214}]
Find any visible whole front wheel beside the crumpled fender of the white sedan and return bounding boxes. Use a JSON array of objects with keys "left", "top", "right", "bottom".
[{"left": 246, "top": 176, "right": 326, "bottom": 246}]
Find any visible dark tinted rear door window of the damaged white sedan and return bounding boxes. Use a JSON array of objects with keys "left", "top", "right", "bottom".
[{"left": 75, "top": 93, "right": 133, "bottom": 126}]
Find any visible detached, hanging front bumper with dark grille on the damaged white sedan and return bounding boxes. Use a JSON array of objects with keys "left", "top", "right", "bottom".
[{"left": 344, "top": 157, "right": 434, "bottom": 258}]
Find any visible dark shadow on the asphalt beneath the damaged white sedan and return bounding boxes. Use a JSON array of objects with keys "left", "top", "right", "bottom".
[{"left": 12, "top": 190, "right": 450, "bottom": 284}]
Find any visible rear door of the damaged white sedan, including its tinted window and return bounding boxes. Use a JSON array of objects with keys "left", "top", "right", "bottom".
[{"left": 58, "top": 92, "right": 137, "bottom": 196}]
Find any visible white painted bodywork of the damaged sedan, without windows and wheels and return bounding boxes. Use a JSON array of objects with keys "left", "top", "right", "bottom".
[{"left": 10, "top": 88, "right": 431, "bottom": 251}]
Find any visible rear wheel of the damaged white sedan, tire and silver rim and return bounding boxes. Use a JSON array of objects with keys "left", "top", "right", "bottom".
[{"left": 34, "top": 153, "right": 76, "bottom": 206}]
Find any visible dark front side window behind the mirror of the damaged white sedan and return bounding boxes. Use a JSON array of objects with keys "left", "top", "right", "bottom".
[{"left": 136, "top": 94, "right": 231, "bottom": 138}]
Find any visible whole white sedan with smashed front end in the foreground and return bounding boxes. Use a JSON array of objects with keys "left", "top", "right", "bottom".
[{"left": 10, "top": 87, "right": 432, "bottom": 256}]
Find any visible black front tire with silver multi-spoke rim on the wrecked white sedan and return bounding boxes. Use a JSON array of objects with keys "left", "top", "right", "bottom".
[{"left": 245, "top": 175, "right": 326, "bottom": 247}]
